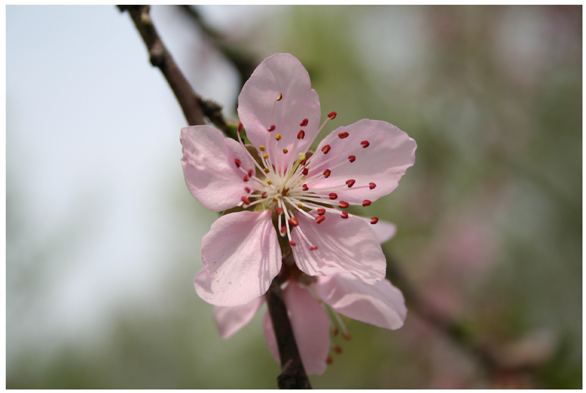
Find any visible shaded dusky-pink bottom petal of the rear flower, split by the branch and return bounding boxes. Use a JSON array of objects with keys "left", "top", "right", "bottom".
[{"left": 263, "top": 281, "right": 330, "bottom": 375}]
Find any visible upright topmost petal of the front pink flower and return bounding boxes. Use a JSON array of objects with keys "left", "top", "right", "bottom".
[{"left": 238, "top": 53, "right": 321, "bottom": 166}]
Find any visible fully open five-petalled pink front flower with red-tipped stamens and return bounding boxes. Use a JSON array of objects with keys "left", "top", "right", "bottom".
[{"left": 181, "top": 53, "right": 416, "bottom": 306}]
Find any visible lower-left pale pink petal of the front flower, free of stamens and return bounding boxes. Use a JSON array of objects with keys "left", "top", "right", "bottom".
[{"left": 194, "top": 210, "right": 281, "bottom": 306}]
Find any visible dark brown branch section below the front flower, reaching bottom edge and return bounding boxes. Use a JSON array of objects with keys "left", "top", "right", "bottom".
[{"left": 265, "top": 276, "right": 311, "bottom": 389}]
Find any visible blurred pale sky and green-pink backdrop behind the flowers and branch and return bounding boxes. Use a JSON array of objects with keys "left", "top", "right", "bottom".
[{"left": 6, "top": 6, "right": 582, "bottom": 388}]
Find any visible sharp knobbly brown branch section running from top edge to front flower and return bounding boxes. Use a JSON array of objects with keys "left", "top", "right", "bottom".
[{"left": 118, "top": 5, "right": 233, "bottom": 136}]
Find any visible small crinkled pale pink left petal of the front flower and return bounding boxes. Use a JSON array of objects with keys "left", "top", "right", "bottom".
[{"left": 181, "top": 126, "right": 255, "bottom": 211}]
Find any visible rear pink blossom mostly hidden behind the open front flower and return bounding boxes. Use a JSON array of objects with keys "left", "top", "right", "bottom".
[{"left": 214, "top": 217, "right": 407, "bottom": 375}]
